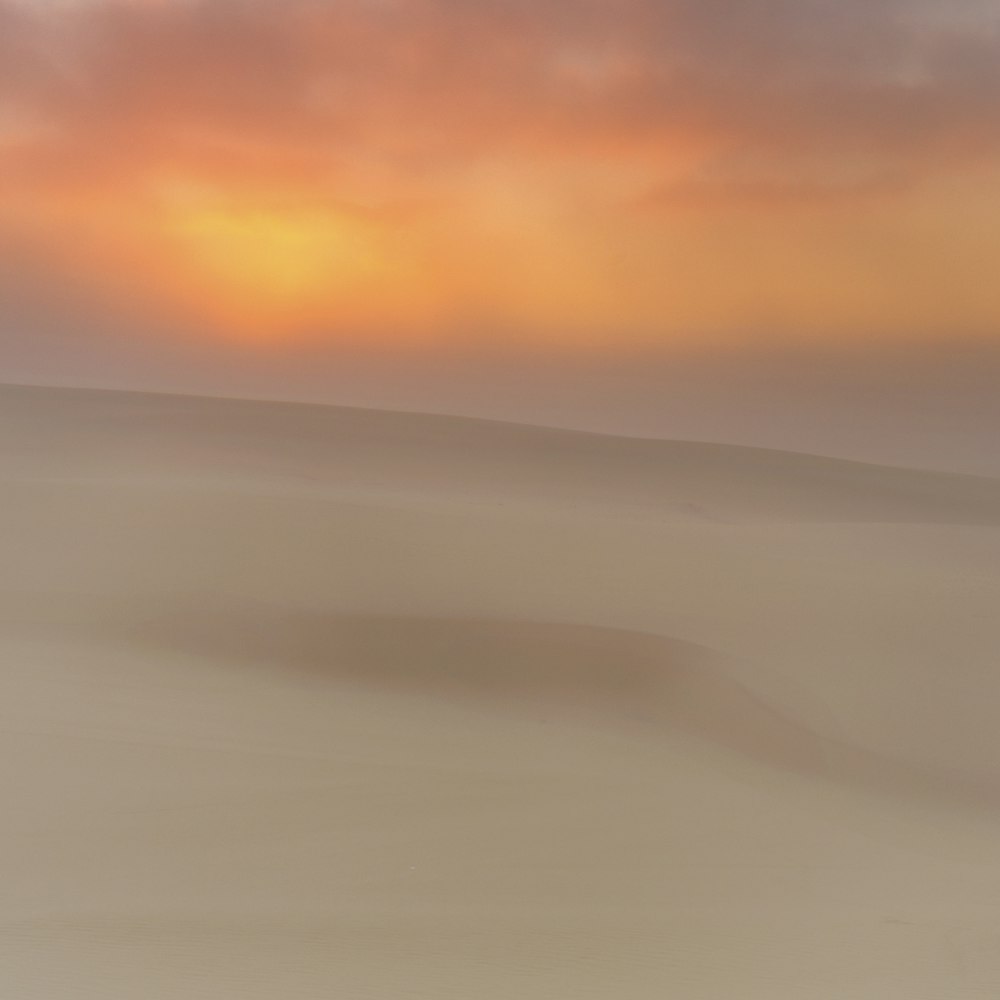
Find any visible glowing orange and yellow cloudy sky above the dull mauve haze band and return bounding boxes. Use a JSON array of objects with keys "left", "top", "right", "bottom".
[{"left": 0, "top": 0, "right": 1000, "bottom": 346}]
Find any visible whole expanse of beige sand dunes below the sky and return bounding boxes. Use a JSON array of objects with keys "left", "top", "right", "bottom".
[{"left": 0, "top": 378, "right": 1000, "bottom": 1000}]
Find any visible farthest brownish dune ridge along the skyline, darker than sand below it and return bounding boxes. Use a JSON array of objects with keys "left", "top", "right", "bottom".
[{"left": 0, "top": 385, "right": 1000, "bottom": 525}]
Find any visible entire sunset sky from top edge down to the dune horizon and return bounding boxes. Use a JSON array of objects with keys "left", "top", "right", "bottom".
[{"left": 0, "top": 0, "right": 1000, "bottom": 474}]
